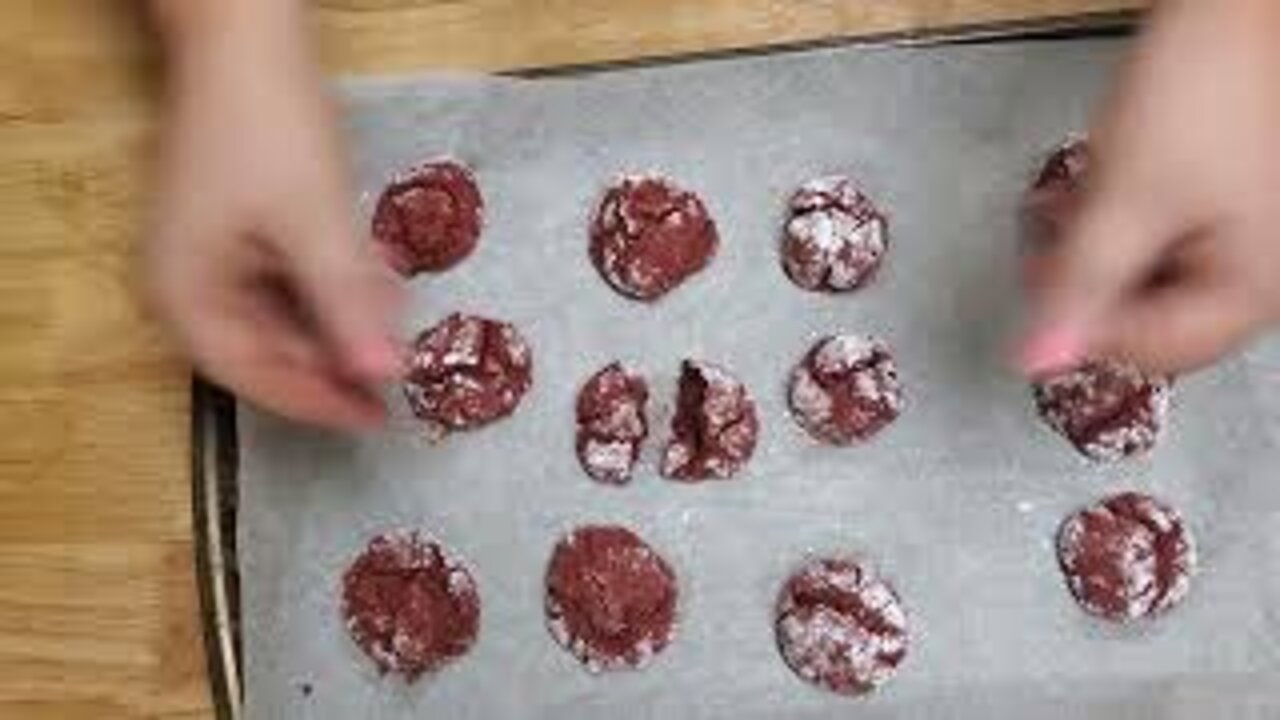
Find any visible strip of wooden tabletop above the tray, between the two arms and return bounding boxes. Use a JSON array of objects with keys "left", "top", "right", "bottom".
[{"left": 317, "top": 0, "right": 1138, "bottom": 72}]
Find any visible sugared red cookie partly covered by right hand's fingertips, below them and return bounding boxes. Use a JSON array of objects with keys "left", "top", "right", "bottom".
[{"left": 1032, "top": 360, "right": 1171, "bottom": 461}]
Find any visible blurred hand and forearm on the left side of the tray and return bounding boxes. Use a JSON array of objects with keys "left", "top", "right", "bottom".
[{"left": 146, "top": 0, "right": 401, "bottom": 427}]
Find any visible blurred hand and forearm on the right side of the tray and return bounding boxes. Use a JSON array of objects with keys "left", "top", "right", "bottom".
[{"left": 1019, "top": 0, "right": 1280, "bottom": 375}]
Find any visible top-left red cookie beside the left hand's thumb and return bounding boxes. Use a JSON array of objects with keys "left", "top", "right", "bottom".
[{"left": 372, "top": 160, "right": 484, "bottom": 277}]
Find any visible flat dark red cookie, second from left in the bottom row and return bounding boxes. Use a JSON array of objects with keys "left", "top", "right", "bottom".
[{"left": 547, "top": 525, "right": 677, "bottom": 673}]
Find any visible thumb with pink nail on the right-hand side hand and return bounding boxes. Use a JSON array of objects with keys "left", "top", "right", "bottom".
[{"left": 1018, "top": 177, "right": 1176, "bottom": 377}]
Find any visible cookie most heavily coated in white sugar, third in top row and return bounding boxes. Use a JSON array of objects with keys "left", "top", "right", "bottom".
[{"left": 782, "top": 177, "right": 888, "bottom": 292}]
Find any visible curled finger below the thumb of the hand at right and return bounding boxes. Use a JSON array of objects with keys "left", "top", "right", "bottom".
[{"left": 1096, "top": 271, "right": 1261, "bottom": 374}]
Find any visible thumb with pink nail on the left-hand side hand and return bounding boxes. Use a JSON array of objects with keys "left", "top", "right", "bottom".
[{"left": 288, "top": 213, "right": 403, "bottom": 382}]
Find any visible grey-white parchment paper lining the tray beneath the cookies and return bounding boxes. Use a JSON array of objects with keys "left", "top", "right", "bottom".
[{"left": 239, "top": 40, "right": 1280, "bottom": 720}]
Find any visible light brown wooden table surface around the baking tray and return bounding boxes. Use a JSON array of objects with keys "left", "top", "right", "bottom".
[{"left": 0, "top": 0, "right": 1140, "bottom": 720}]
